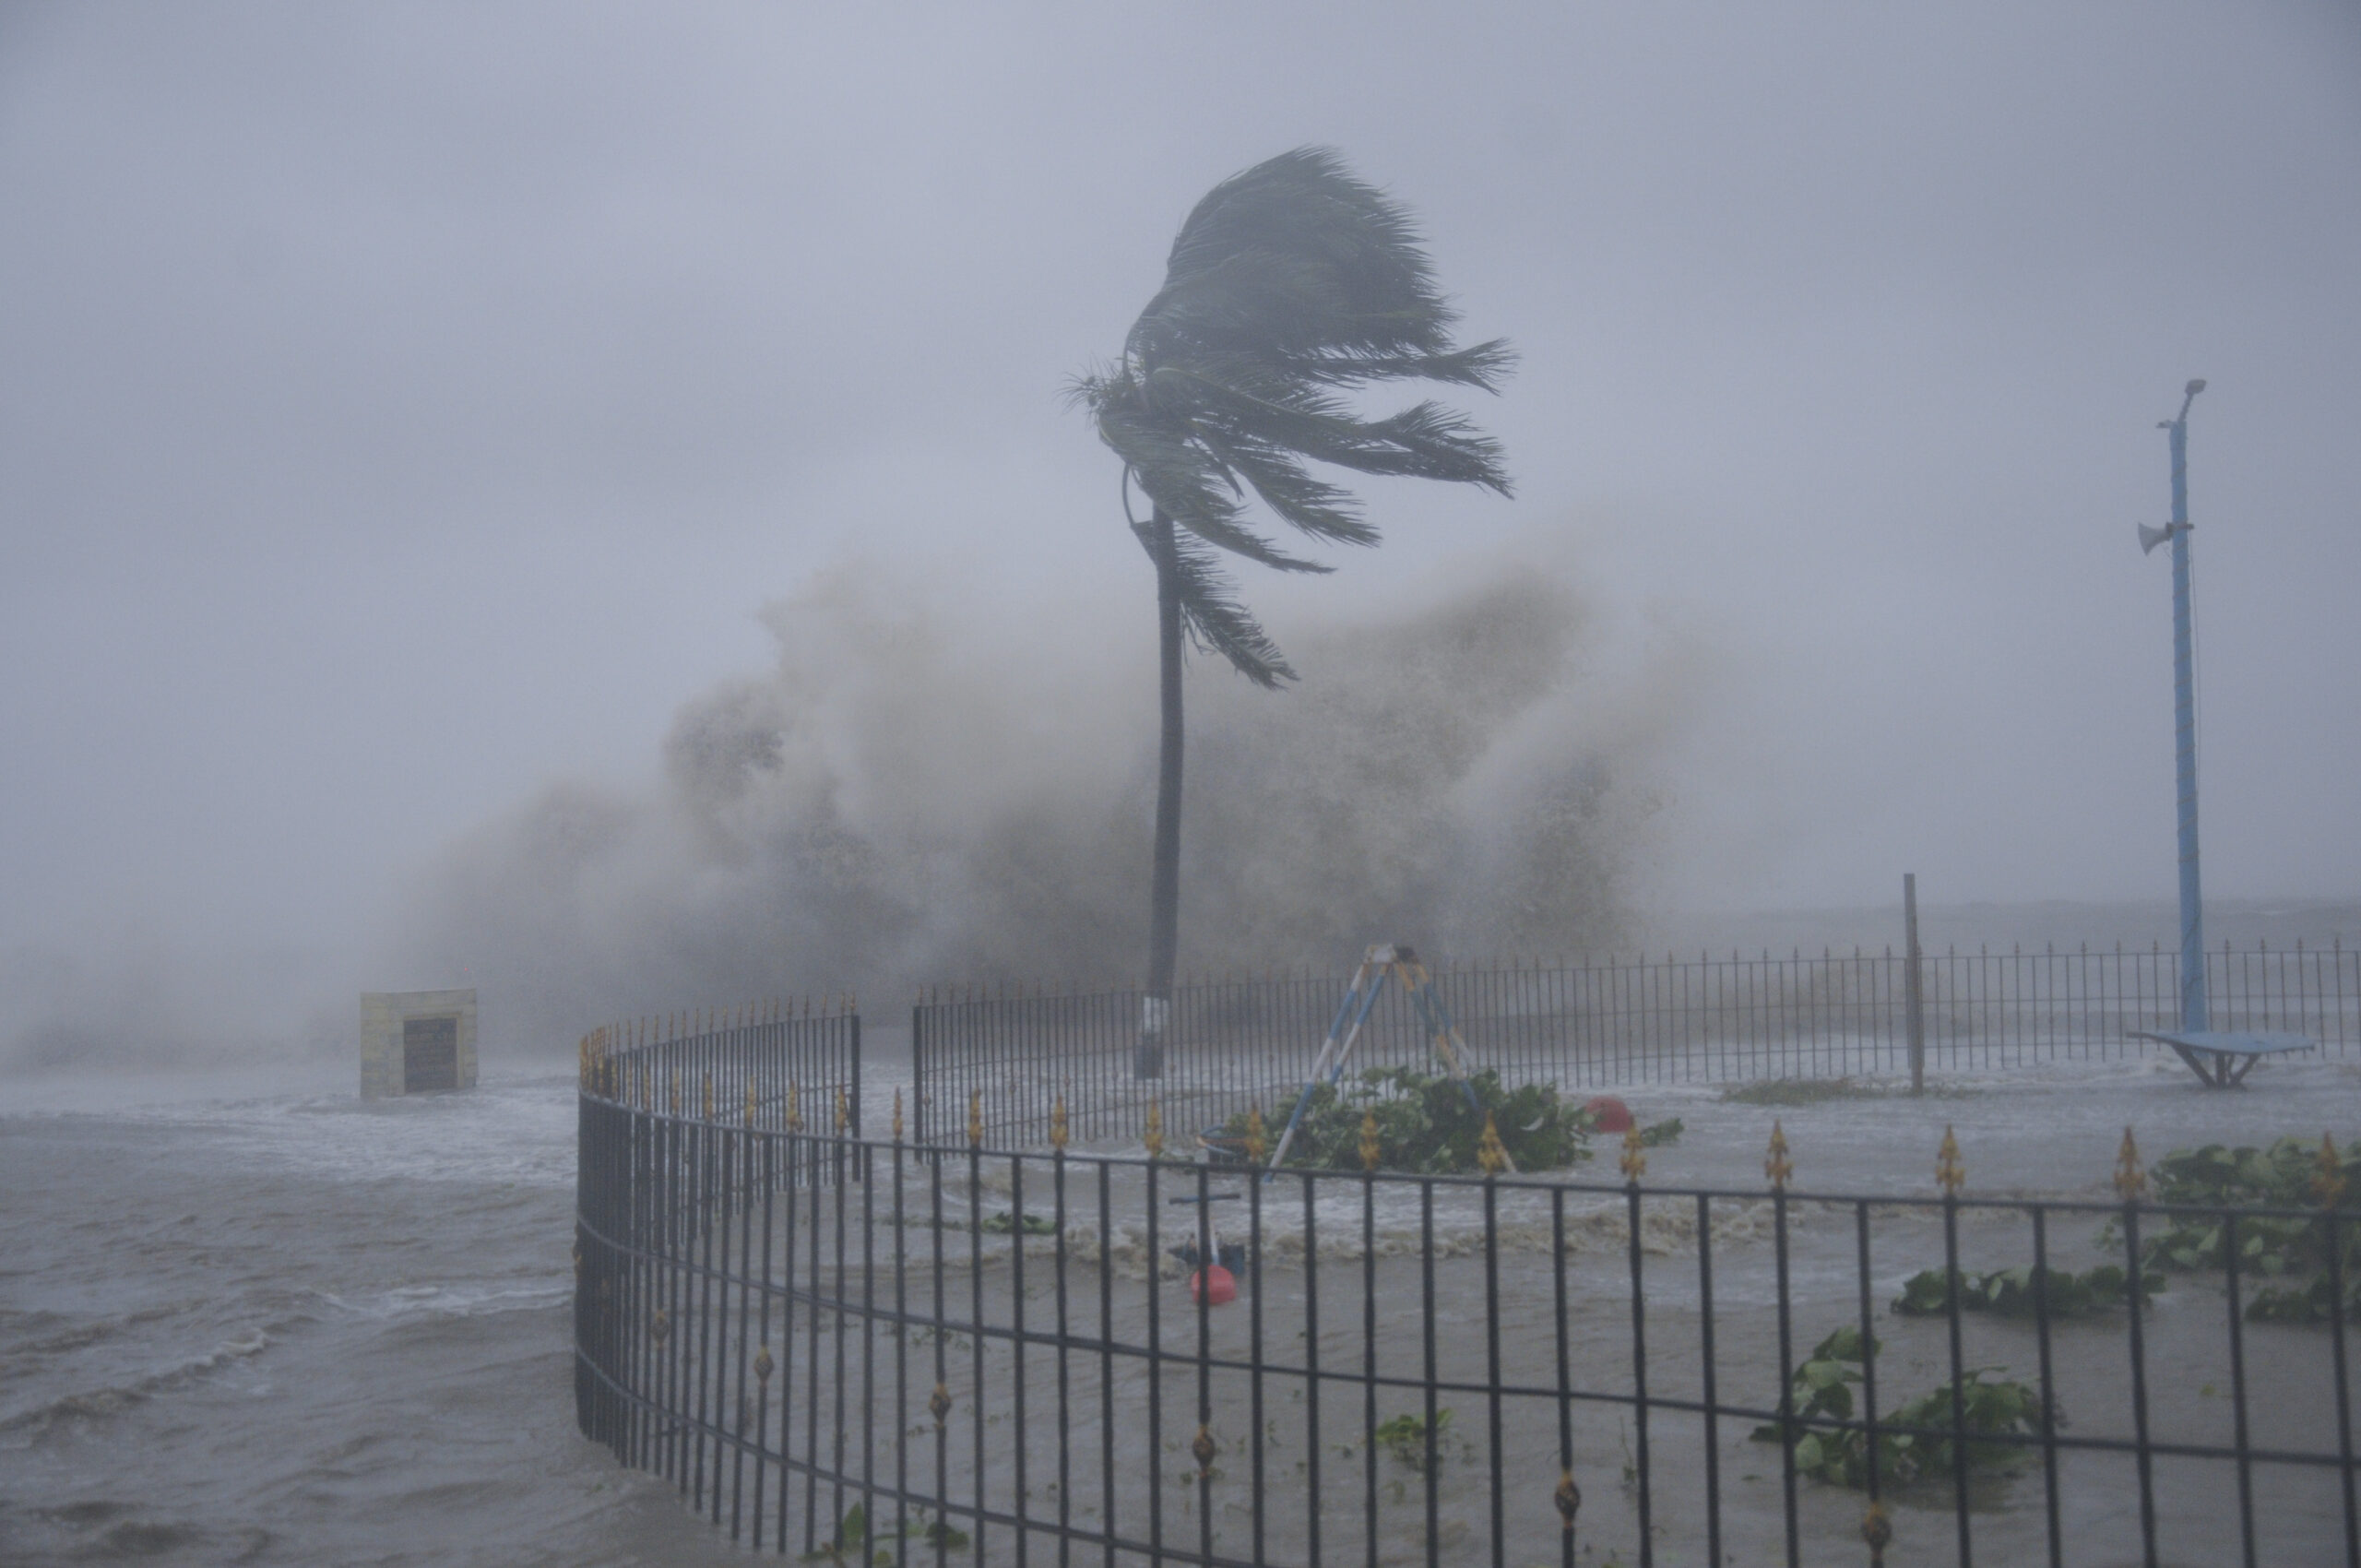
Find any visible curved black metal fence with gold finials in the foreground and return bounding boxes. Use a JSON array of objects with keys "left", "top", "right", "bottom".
[{"left": 576, "top": 1061, "right": 2361, "bottom": 1568}]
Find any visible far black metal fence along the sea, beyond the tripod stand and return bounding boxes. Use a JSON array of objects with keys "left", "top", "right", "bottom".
[{"left": 911, "top": 943, "right": 2361, "bottom": 1146}]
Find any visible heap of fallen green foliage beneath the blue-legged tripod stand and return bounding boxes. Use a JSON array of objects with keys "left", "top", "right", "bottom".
[{"left": 1221, "top": 1067, "right": 1591, "bottom": 1176}]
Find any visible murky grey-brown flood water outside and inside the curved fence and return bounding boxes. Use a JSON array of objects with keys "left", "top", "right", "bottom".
[{"left": 0, "top": 1034, "right": 2361, "bottom": 1565}]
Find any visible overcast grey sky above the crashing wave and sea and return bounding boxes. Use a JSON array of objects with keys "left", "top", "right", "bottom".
[{"left": 0, "top": 0, "right": 2361, "bottom": 1039}]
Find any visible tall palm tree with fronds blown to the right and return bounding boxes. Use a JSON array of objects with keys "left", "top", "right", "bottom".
[{"left": 1074, "top": 147, "right": 1513, "bottom": 1076}]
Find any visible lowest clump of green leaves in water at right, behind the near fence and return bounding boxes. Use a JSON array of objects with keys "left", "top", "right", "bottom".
[{"left": 1750, "top": 1327, "right": 2042, "bottom": 1488}]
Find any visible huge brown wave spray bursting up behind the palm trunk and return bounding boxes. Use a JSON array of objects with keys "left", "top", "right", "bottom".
[{"left": 409, "top": 545, "right": 1703, "bottom": 1039}]
